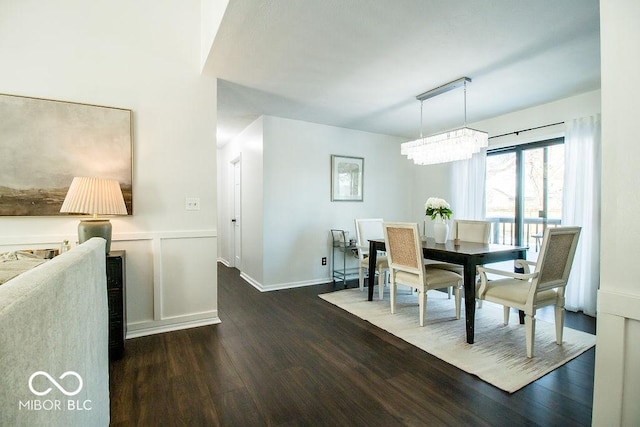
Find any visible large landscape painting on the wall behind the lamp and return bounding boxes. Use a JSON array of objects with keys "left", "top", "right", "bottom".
[{"left": 0, "top": 94, "right": 133, "bottom": 216}]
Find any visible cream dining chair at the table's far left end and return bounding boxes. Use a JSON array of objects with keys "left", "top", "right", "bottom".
[{"left": 355, "top": 218, "right": 389, "bottom": 299}]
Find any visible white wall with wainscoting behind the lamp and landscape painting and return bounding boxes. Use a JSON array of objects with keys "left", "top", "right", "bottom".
[{"left": 0, "top": 0, "right": 219, "bottom": 336}]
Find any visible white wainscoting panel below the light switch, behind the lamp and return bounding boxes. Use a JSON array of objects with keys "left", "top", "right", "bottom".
[{"left": 0, "top": 230, "right": 220, "bottom": 338}]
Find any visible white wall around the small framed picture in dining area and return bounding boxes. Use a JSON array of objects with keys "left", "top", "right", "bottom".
[{"left": 263, "top": 117, "right": 411, "bottom": 288}]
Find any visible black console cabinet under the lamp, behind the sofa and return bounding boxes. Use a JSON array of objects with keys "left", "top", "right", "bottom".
[{"left": 107, "top": 251, "right": 127, "bottom": 360}]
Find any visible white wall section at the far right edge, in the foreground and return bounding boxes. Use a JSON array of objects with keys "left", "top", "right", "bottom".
[{"left": 593, "top": 0, "right": 640, "bottom": 426}]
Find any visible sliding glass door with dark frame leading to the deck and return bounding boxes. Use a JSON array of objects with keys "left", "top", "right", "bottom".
[{"left": 485, "top": 138, "right": 564, "bottom": 259}]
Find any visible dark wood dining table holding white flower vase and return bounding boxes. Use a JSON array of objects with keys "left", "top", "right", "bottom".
[{"left": 368, "top": 238, "right": 529, "bottom": 344}]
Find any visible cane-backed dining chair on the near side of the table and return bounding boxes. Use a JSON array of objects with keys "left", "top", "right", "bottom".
[{"left": 382, "top": 222, "right": 462, "bottom": 326}]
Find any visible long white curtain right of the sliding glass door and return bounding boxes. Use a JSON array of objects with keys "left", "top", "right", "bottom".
[{"left": 562, "top": 114, "right": 601, "bottom": 316}]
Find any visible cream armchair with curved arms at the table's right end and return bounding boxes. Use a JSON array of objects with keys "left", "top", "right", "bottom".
[{"left": 476, "top": 227, "right": 580, "bottom": 358}]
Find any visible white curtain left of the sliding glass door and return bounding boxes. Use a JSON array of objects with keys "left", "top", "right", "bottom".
[{"left": 451, "top": 148, "right": 487, "bottom": 220}]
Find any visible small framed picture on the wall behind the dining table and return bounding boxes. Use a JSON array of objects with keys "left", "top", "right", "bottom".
[{"left": 331, "top": 154, "right": 364, "bottom": 202}]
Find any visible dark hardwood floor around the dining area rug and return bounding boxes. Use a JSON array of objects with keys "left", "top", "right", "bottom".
[{"left": 110, "top": 264, "right": 595, "bottom": 426}]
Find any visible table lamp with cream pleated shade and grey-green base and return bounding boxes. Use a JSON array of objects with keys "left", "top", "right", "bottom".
[{"left": 60, "top": 177, "right": 127, "bottom": 254}]
